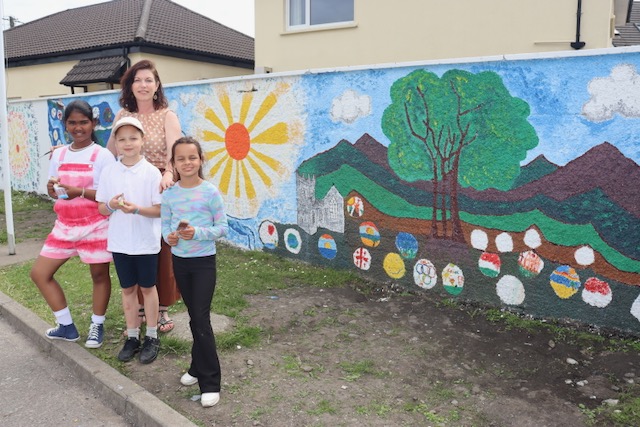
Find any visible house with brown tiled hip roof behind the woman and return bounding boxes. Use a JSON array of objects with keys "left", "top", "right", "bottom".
[{"left": 4, "top": 0, "right": 254, "bottom": 99}]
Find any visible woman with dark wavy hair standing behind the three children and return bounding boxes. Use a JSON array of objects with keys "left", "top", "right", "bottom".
[{"left": 107, "top": 59, "right": 181, "bottom": 332}]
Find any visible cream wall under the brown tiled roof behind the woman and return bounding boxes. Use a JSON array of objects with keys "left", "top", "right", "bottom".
[{"left": 7, "top": 53, "right": 253, "bottom": 99}]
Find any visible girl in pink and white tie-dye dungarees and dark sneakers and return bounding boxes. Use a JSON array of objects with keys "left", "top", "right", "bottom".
[{"left": 31, "top": 100, "right": 115, "bottom": 348}]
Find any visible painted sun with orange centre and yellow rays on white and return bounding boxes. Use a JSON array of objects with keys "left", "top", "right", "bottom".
[{"left": 195, "top": 82, "right": 304, "bottom": 218}]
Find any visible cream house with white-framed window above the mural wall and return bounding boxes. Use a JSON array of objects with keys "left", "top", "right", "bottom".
[{"left": 255, "top": 0, "right": 632, "bottom": 72}]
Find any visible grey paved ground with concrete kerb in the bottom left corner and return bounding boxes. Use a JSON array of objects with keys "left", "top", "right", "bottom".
[{"left": 0, "top": 242, "right": 194, "bottom": 427}]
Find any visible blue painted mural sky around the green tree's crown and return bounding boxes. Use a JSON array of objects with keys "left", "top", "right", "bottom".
[{"left": 300, "top": 48, "right": 640, "bottom": 165}]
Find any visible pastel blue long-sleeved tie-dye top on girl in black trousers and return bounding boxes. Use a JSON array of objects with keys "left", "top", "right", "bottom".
[{"left": 161, "top": 181, "right": 229, "bottom": 258}]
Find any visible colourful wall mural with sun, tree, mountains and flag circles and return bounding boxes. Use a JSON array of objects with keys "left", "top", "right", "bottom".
[{"left": 5, "top": 50, "right": 640, "bottom": 335}]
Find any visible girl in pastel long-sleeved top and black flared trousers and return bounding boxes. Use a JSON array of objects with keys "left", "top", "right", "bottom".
[{"left": 161, "top": 137, "right": 228, "bottom": 407}]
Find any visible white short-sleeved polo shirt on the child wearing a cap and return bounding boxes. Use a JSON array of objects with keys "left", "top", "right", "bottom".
[{"left": 96, "top": 158, "right": 162, "bottom": 255}]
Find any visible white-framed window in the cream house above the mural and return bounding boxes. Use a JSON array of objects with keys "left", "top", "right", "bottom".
[{"left": 287, "top": 0, "right": 354, "bottom": 28}]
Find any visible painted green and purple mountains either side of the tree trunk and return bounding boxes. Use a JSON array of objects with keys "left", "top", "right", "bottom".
[{"left": 298, "top": 134, "right": 640, "bottom": 273}]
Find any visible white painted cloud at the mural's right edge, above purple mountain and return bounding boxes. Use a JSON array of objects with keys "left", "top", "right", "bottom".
[{"left": 582, "top": 64, "right": 640, "bottom": 123}]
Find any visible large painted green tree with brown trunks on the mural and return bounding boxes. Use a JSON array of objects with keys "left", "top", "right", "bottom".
[{"left": 382, "top": 70, "right": 538, "bottom": 241}]
